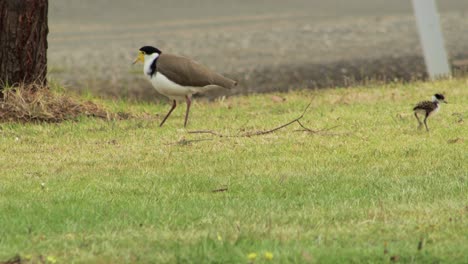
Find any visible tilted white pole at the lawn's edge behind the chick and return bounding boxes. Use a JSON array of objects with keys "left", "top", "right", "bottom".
[{"left": 413, "top": 0, "right": 450, "bottom": 79}]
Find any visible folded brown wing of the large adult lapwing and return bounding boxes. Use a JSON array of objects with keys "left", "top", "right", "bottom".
[{"left": 157, "top": 53, "right": 237, "bottom": 88}]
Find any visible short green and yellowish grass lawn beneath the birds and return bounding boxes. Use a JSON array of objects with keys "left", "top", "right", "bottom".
[{"left": 0, "top": 79, "right": 468, "bottom": 263}]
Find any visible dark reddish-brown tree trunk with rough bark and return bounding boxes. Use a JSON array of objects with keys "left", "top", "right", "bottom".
[{"left": 0, "top": 0, "right": 49, "bottom": 90}]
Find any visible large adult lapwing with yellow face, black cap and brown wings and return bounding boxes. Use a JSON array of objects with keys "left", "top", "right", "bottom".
[{"left": 133, "top": 46, "right": 237, "bottom": 127}]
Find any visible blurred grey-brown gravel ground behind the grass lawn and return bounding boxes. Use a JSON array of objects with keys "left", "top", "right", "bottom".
[{"left": 48, "top": 0, "right": 468, "bottom": 101}]
